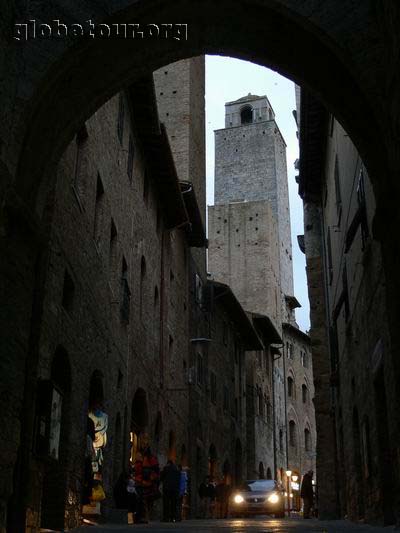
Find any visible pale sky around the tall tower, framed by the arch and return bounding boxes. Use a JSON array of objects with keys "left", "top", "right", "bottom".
[{"left": 206, "top": 56, "right": 310, "bottom": 331}]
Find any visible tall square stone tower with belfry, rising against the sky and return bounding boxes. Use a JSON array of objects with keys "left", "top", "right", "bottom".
[{"left": 209, "top": 94, "right": 294, "bottom": 329}]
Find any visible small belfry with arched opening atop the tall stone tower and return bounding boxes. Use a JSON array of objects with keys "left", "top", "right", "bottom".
[{"left": 225, "top": 93, "right": 275, "bottom": 128}]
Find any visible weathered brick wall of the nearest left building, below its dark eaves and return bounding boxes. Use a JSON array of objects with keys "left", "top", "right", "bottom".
[{"left": 23, "top": 91, "right": 192, "bottom": 527}]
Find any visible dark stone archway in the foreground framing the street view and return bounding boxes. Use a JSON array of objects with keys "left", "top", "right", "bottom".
[{"left": 0, "top": 0, "right": 400, "bottom": 528}]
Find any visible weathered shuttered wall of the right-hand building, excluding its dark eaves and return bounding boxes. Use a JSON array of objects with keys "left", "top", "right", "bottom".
[{"left": 323, "top": 120, "right": 395, "bottom": 523}]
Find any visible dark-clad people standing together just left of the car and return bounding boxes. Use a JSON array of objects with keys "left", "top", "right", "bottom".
[{"left": 199, "top": 476, "right": 231, "bottom": 518}]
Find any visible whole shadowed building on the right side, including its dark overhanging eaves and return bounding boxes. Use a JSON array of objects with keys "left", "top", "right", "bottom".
[{"left": 299, "top": 91, "right": 399, "bottom": 524}]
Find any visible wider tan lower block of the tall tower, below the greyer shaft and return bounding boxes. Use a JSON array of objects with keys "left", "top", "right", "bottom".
[{"left": 208, "top": 201, "right": 281, "bottom": 328}]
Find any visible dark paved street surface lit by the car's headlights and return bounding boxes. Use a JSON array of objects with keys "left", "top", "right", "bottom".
[{"left": 79, "top": 517, "right": 394, "bottom": 533}]
